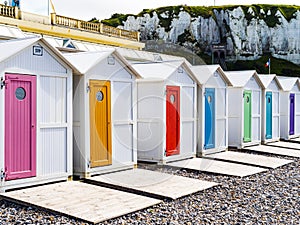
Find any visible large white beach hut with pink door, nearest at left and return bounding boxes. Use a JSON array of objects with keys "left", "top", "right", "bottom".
[{"left": 0, "top": 37, "right": 74, "bottom": 191}]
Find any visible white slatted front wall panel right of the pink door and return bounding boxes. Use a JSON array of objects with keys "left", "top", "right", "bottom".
[{"left": 39, "top": 76, "right": 67, "bottom": 175}]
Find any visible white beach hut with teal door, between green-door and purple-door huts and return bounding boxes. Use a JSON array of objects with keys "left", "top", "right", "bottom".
[{"left": 258, "top": 74, "right": 282, "bottom": 144}]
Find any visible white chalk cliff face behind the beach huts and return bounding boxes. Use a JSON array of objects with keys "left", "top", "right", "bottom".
[{"left": 122, "top": 7, "right": 300, "bottom": 64}]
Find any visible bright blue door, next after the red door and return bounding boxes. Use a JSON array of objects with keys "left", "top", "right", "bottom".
[{"left": 204, "top": 88, "right": 215, "bottom": 149}]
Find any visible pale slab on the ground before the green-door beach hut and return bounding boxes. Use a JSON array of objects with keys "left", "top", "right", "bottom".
[{"left": 245, "top": 145, "right": 300, "bottom": 158}]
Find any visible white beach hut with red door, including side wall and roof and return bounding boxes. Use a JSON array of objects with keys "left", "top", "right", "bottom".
[{"left": 132, "top": 61, "right": 197, "bottom": 163}]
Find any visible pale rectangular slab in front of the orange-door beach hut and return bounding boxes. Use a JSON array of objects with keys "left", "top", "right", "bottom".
[{"left": 86, "top": 169, "right": 218, "bottom": 199}]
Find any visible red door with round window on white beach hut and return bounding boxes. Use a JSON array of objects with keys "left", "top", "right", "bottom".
[{"left": 166, "top": 86, "right": 180, "bottom": 156}]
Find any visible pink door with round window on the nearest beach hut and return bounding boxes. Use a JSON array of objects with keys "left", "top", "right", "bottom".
[{"left": 4, "top": 74, "right": 36, "bottom": 180}]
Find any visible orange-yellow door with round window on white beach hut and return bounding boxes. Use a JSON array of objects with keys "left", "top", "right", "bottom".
[{"left": 89, "top": 80, "right": 112, "bottom": 167}]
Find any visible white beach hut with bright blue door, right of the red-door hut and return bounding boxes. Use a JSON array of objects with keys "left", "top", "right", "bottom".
[{"left": 191, "top": 65, "right": 231, "bottom": 155}]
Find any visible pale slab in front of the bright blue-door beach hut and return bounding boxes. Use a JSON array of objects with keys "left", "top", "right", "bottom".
[{"left": 205, "top": 151, "right": 293, "bottom": 169}]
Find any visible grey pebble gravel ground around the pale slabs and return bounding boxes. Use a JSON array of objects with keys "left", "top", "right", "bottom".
[{"left": 0, "top": 151, "right": 300, "bottom": 225}]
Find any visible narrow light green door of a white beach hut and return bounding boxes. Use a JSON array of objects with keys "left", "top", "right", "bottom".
[{"left": 244, "top": 91, "right": 252, "bottom": 142}]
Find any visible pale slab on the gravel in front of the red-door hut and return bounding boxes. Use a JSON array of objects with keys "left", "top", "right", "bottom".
[{"left": 167, "top": 158, "right": 267, "bottom": 177}]
